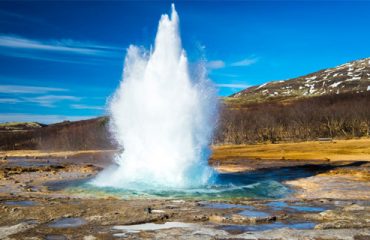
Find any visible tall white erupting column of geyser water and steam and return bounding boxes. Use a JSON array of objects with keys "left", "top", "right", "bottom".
[{"left": 92, "top": 5, "right": 217, "bottom": 189}]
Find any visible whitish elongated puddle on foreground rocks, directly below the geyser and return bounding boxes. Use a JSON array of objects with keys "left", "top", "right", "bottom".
[{"left": 112, "top": 222, "right": 194, "bottom": 233}]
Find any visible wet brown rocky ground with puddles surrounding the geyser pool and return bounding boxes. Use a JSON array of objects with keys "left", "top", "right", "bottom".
[{"left": 0, "top": 155, "right": 370, "bottom": 240}]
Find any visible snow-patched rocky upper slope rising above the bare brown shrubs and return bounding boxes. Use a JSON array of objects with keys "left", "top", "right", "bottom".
[{"left": 226, "top": 58, "right": 370, "bottom": 103}]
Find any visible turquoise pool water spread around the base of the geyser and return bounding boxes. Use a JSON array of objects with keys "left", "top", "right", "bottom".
[{"left": 48, "top": 167, "right": 312, "bottom": 199}]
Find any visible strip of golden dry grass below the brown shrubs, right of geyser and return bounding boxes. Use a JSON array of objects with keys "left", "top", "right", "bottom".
[{"left": 211, "top": 138, "right": 370, "bottom": 161}]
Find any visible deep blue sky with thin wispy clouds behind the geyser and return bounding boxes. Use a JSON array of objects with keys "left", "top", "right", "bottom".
[{"left": 0, "top": 1, "right": 370, "bottom": 123}]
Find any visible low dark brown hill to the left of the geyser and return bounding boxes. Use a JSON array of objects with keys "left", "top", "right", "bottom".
[{"left": 0, "top": 117, "right": 114, "bottom": 150}]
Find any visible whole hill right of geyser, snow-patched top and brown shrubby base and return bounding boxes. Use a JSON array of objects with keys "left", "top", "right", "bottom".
[{"left": 214, "top": 58, "right": 370, "bottom": 144}]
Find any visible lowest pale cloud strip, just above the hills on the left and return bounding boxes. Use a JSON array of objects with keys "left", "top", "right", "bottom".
[{"left": 0, "top": 113, "right": 97, "bottom": 124}]
